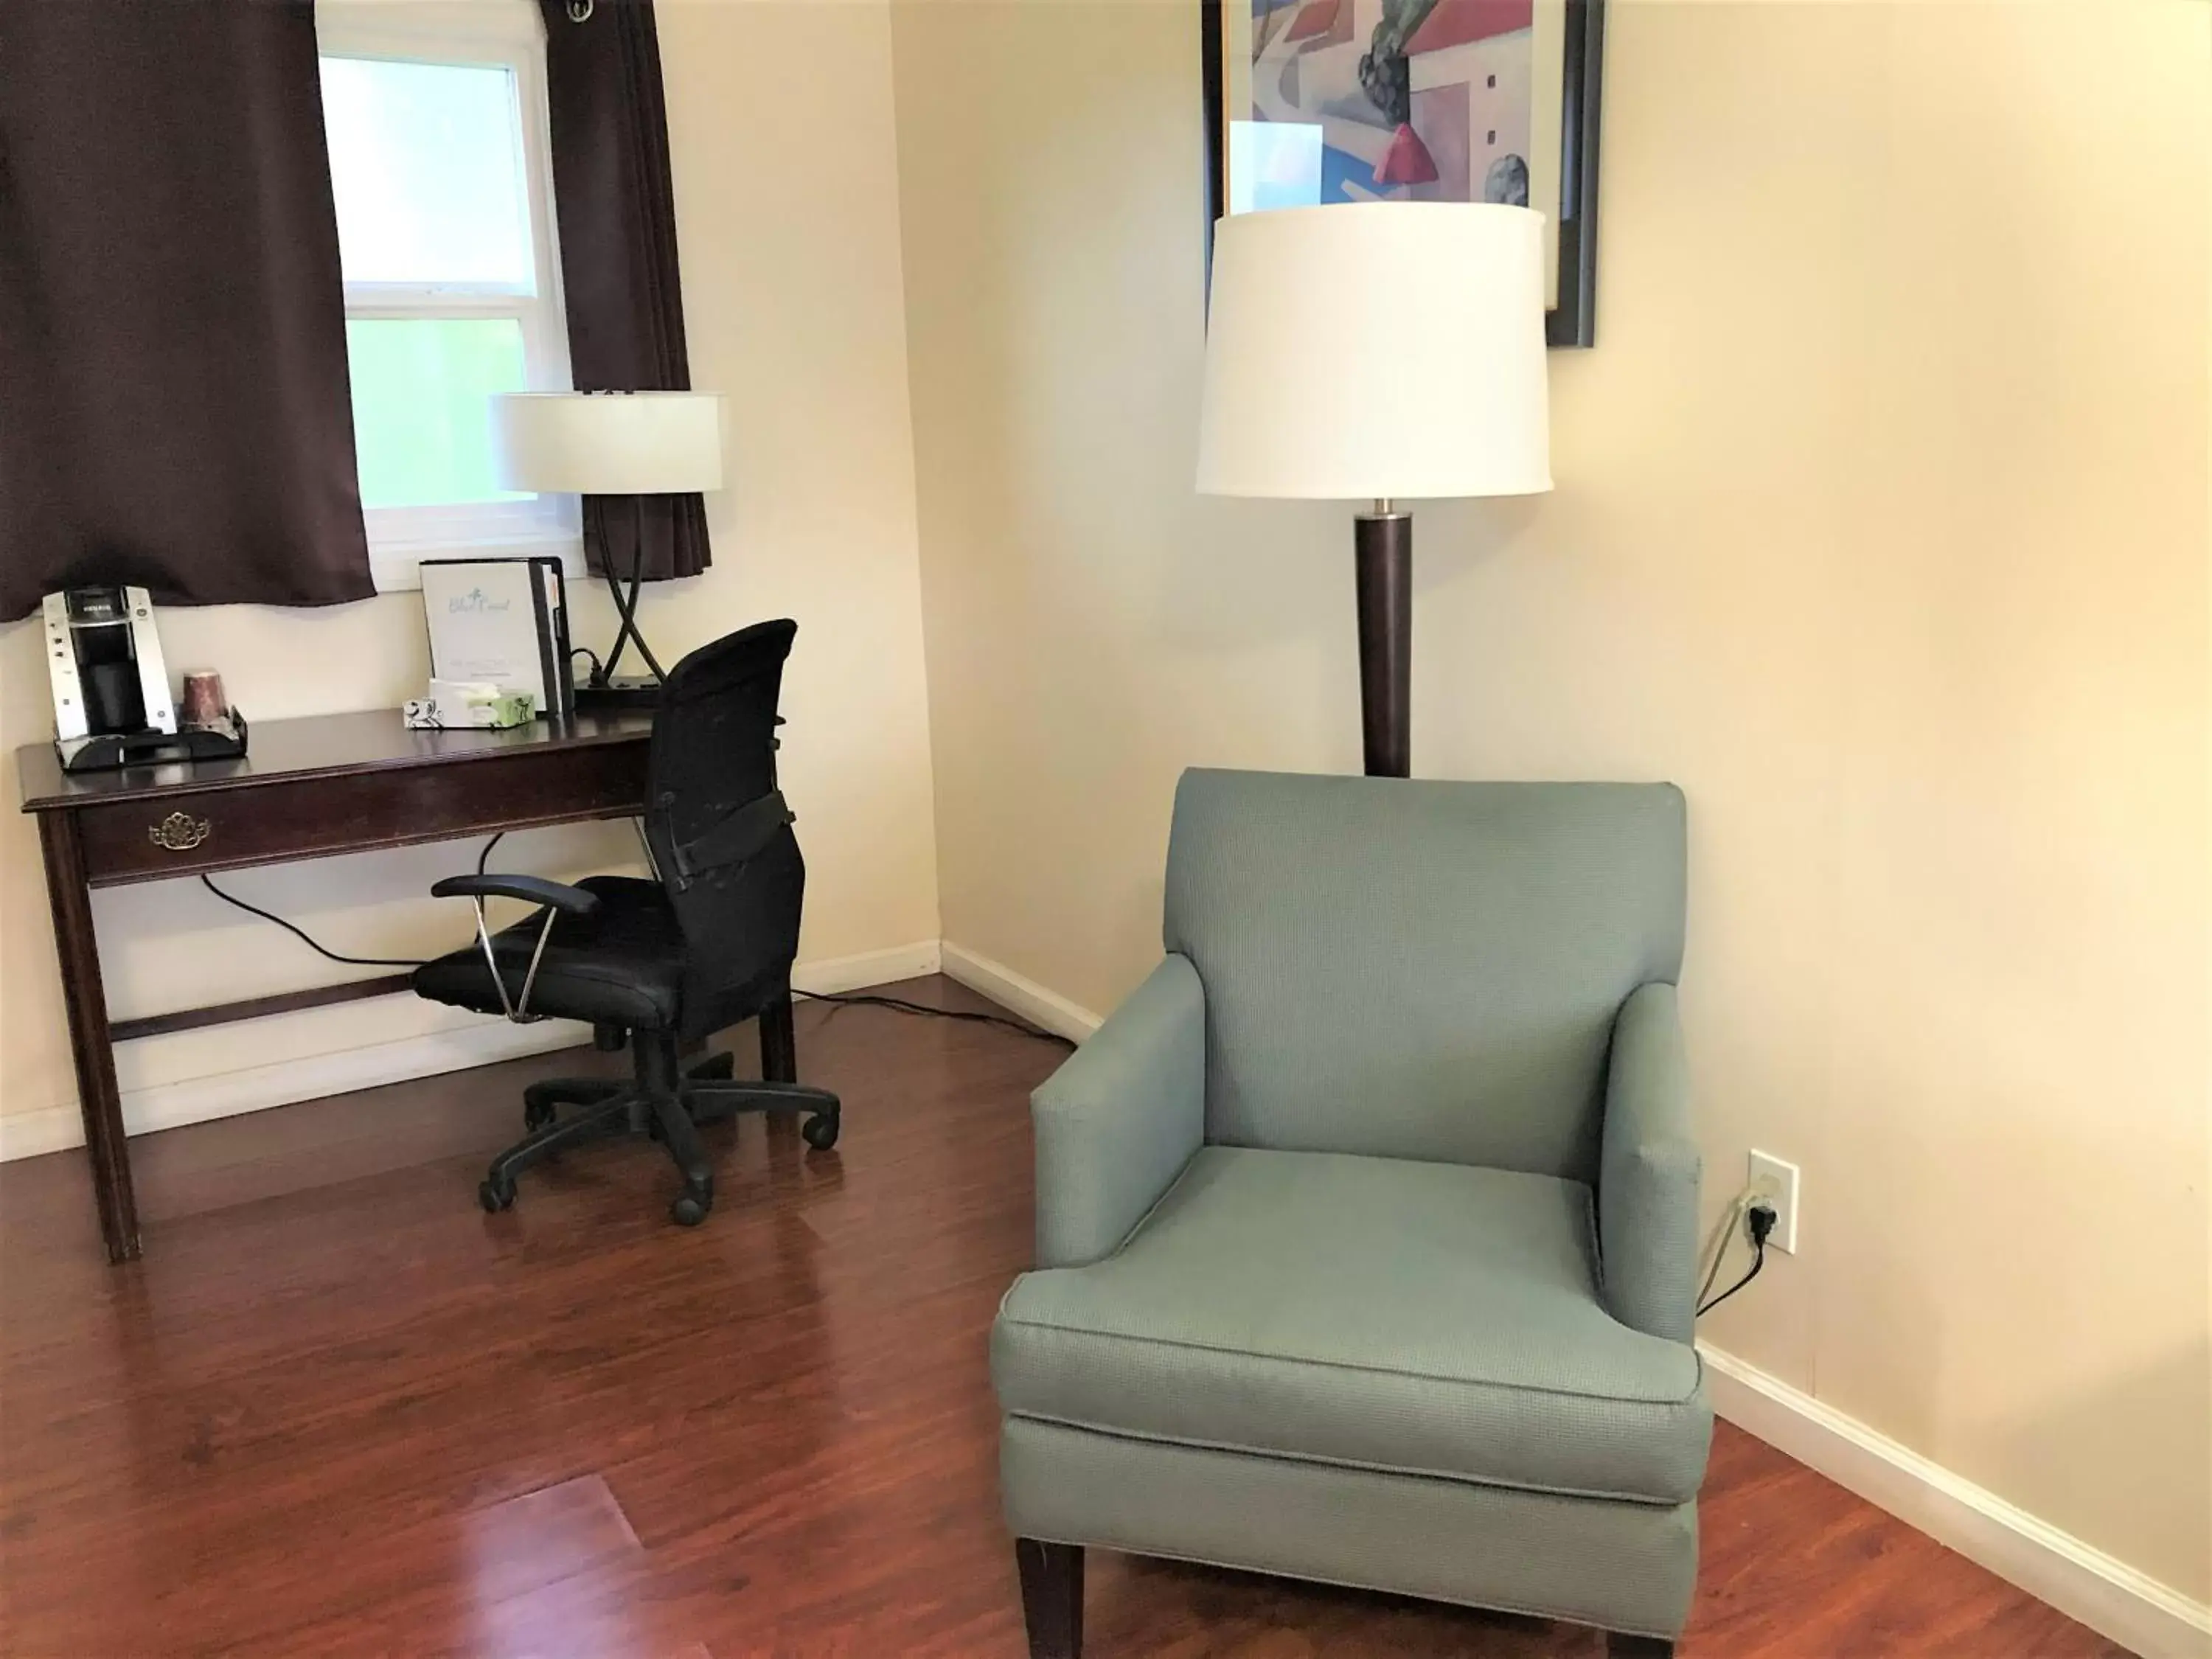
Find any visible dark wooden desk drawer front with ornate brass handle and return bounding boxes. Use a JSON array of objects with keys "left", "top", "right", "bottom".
[{"left": 77, "top": 741, "right": 646, "bottom": 887}]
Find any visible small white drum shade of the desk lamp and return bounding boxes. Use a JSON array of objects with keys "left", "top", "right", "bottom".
[{"left": 491, "top": 392, "right": 721, "bottom": 495}]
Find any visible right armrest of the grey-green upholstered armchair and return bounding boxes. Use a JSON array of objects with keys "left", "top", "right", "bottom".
[{"left": 1597, "top": 984, "right": 1703, "bottom": 1343}]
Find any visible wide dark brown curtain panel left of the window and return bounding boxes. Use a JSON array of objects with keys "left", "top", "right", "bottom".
[{"left": 0, "top": 0, "right": 374, "bottom": 622}]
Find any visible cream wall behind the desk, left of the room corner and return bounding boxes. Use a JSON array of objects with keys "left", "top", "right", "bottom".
[{"left": 0, "top": 0, "right": 938, "bottom": 1115}]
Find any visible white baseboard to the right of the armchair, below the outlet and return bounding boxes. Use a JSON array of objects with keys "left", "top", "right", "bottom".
[{"left": 1699, "top": 1343, "right": 2212, "bottom": 1659}]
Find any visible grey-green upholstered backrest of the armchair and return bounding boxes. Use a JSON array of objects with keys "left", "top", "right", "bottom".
[{"left": 1166, "top": 770, "right": 1686, "bottom": 1181}]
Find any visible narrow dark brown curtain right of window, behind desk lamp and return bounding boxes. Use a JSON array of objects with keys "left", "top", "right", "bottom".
[{"left": 538, "top": 0, "right": 708, "bottom": 582}]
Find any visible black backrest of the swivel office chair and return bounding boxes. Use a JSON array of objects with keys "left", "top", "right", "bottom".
[{"left": 646, "top": 619, "right": 807, "bottom": 1031}]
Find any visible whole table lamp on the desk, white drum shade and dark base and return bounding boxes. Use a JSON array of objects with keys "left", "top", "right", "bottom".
[{"left": 491, "top": 392, "right": 721, "bottom": 710}]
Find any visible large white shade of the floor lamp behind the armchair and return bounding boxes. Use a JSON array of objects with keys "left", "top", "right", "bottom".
[{"left": 1199, "top": 201, "right": 1551, "bottom": 500}]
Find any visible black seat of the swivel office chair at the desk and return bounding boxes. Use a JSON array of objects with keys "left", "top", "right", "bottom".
[{"left": 414, "top": 876, "right": 684, "bottom": 1031}]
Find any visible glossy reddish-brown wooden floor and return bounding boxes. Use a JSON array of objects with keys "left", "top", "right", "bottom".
[{"left": 0, "top": 980, "right": 2119, "bottom": 1659}]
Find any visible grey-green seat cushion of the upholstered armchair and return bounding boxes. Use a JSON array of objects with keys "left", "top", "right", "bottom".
[{"left": 991, "top": 1146, "right": 1712, "bottom": 1504}]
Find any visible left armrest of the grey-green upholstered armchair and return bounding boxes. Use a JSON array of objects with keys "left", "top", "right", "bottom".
[{"left": 1029, "top": 956, "right": 1206, "bottom": 1267}]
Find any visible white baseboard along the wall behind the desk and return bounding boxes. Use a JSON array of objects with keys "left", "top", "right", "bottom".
[{"left": 0, "top": 940, "right": 938, "bottom": 1164}]
